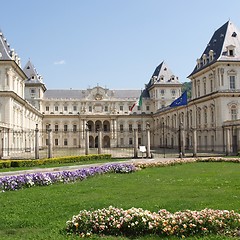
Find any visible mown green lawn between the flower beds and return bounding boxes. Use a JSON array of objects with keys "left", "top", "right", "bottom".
[{"left": 0, "top": 162, "right": 240, "bottom": 240}]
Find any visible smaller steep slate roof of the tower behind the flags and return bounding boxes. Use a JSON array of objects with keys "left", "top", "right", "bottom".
[{"left": 147, "top": 61, "right": 181, "bottom": 89}]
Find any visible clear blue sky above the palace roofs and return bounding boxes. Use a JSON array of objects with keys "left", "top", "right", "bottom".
[{"left": 0, "top": 0, "right": 240, "bottom": 89}]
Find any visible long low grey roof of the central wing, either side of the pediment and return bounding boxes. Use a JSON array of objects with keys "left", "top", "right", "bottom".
[{"left": 44, "top": 89, "right": 149, "bottom": 100}]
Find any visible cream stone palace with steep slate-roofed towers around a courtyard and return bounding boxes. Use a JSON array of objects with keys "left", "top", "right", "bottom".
[{"left": 0, "top": 21, "right": 240, "bottom": 158}]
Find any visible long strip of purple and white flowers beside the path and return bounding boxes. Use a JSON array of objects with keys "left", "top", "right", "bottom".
[{"left": 0, "top": 164, "right": 135, "bottom": 192}]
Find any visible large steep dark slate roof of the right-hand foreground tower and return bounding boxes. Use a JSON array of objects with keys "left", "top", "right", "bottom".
[{"left": 188, "top": 21, "right": 240, "bottom": 77}]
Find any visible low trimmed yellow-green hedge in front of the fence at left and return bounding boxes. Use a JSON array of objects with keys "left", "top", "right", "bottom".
[{"left": 0, "top": 154, "right": 112, "bottom": 168}]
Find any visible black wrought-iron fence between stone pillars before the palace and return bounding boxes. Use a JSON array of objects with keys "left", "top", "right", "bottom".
[{"left": 0, "top": 126, "right": 236, "bottom": 159}]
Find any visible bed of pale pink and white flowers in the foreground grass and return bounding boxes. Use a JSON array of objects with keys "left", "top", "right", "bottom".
[{"left": 66, "top": 206, "right": 240, "bottom": 238}]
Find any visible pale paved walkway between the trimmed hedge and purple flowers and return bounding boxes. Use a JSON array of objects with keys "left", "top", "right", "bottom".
[{"left": 0, "top": 158, "right": 176, "bottom": 178}]
